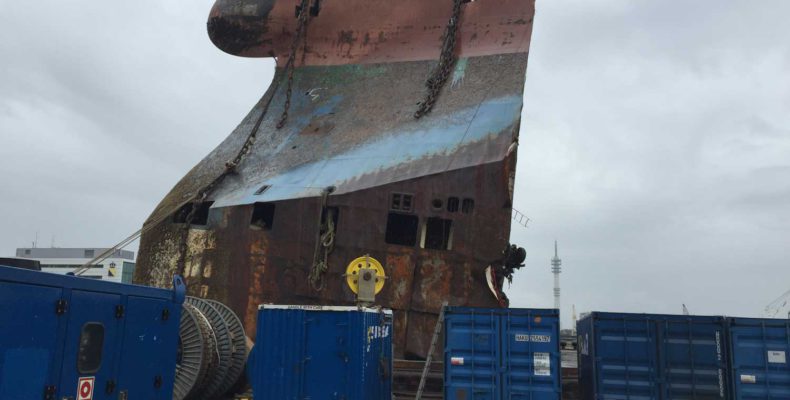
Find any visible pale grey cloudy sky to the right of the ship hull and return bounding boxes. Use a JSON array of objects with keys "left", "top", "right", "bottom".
[{"left": 511, "top": 1, "right": 790, "bottom": 323}]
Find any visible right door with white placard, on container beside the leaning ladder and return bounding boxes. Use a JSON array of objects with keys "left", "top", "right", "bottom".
[{"left": 501, "top": 310, "right": 562, "bottom": 400}]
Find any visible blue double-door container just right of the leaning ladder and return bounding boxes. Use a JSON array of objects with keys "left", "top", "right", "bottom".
[{"left": 444, "top": 307, "right": 562, "bottom": 400}]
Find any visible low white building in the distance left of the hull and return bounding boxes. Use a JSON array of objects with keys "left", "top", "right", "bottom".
[{"left": 16, "top": 247, "right": 134, "bottom": 283}]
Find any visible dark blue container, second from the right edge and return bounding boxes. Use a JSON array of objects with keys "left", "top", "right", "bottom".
[{"left": 576, "top": 312, "right": 729, "bottom": 400}]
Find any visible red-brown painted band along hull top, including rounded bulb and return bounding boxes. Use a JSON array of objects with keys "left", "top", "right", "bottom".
[{"left": 209, "top": 0, "right": 535, "bottom": 65}]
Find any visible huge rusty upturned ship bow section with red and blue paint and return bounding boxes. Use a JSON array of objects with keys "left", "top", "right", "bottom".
[{"left": 135, "top": 0, "right": 534, "bottom": 358}]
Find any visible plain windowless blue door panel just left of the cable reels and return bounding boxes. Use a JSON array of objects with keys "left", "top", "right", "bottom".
[{"left": 118, "top": 296, "right": 179, "bottom": 400}]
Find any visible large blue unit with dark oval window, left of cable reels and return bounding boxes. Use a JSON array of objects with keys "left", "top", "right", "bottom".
[{"left": 0, "top": 267, "right": 185, "bottom": 400}]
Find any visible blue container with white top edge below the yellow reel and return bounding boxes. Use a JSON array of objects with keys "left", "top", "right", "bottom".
[{"left": 248, "top": 305, "right": 392, "bottom": 400}]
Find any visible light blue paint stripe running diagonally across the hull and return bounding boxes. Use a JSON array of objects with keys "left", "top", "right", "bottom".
[{"left": 214, "top": 96, "right": 523, "bottom": 207}]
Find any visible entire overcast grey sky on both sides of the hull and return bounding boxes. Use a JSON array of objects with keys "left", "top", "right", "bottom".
[{"left": 0, "top": 0, "right": 790, "bottom": 322}]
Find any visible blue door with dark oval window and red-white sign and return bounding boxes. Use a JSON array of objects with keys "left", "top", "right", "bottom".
[{"left": 60, "top": 290, "right": 121, "bottom": 400}]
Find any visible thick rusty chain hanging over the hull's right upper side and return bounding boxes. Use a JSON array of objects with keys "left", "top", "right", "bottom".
[{"left": 414, "top": 0, "right": 468, "bottom": 119}]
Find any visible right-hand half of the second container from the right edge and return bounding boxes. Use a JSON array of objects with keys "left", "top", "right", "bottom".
[{"left": 656, "top": 318, "right": 727, "bottom": 400}]
